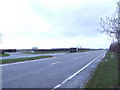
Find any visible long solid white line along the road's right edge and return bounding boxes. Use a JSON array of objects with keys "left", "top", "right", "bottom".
[{"left": 52, "top": 54, "right": 102, "bottom": 90}]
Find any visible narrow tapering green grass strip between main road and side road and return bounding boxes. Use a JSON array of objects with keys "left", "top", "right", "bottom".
[{"left": 0, "top": 56, "right": 53, "bottom": 64}]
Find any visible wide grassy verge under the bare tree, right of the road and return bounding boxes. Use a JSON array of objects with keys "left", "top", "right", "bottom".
[{"left": 85, "top": 51, "right": 118, "bottom": 88}]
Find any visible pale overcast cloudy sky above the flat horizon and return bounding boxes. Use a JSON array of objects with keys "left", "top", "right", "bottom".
[{"left": 0, "top": 0, "right": 117, "bottom": 49}]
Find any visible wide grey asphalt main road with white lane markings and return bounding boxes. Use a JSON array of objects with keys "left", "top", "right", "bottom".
[{"left": 2, "top": 50, "right": 106, "bottom": 89}]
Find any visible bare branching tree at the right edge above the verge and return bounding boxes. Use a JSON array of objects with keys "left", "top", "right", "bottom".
[{"left": 99, "top": 1, "right": 120, "bottom": 43}]
